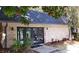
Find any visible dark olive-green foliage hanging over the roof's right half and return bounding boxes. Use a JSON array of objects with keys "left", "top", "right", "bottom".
[{"left": 42, "top": 6, "right": 64, "bottom": 18}]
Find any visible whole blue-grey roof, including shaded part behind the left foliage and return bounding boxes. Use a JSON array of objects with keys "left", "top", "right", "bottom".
[{"left": 0, "top": 10, "right": 67, "bottom": 24}]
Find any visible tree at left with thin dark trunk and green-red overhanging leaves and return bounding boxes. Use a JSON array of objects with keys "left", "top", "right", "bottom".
[{"left": 0, "top": 6, "right": 37, "bottom": 48}]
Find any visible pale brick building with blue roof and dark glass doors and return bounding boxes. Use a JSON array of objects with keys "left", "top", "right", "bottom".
[{"left": 0, "top": 10, "right": 69, "bottom": 47}]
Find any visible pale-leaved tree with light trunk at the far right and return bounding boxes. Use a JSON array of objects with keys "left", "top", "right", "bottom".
[{"left": 66, "top": 7, "right": 79, "bottom": 39}]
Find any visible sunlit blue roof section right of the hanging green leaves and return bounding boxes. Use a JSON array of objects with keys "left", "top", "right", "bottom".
[{"left": 27, "top": 10, "right": 67, "bottom": 24}]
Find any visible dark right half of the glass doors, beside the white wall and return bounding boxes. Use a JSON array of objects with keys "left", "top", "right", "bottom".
[{"left": 31, "top": 28, "right": 44, "bottom": 44}]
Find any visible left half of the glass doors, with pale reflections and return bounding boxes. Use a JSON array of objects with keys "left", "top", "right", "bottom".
[{"left": 17, "top": 27, "right": 31, "bottom": 44}]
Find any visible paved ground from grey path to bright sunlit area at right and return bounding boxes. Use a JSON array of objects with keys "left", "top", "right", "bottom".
[{"left": 32, "top": 41, "right": 79, "bottom": 53}]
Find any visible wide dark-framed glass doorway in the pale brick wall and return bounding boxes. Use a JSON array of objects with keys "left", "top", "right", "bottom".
[{"left": 17, "top": 27, "right": 44, "bottom": 47}]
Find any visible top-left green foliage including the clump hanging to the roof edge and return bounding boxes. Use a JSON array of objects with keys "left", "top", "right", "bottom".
[{"left": 1, "top": 6, "right": 30, "bottom": 24}]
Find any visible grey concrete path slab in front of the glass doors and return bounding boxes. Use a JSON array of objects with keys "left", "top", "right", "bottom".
[{"left": 32, "top": 45, "right": 60, "bottom": 53}]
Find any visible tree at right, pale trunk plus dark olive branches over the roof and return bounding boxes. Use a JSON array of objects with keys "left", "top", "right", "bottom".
[{"left": 42, "top": 6, "right": 79, "bottom": 39}]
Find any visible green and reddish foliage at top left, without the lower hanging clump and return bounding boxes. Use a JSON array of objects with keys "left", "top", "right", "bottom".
[{"left": 2, "top": 6, "right": 29, "bottom": 17}]
